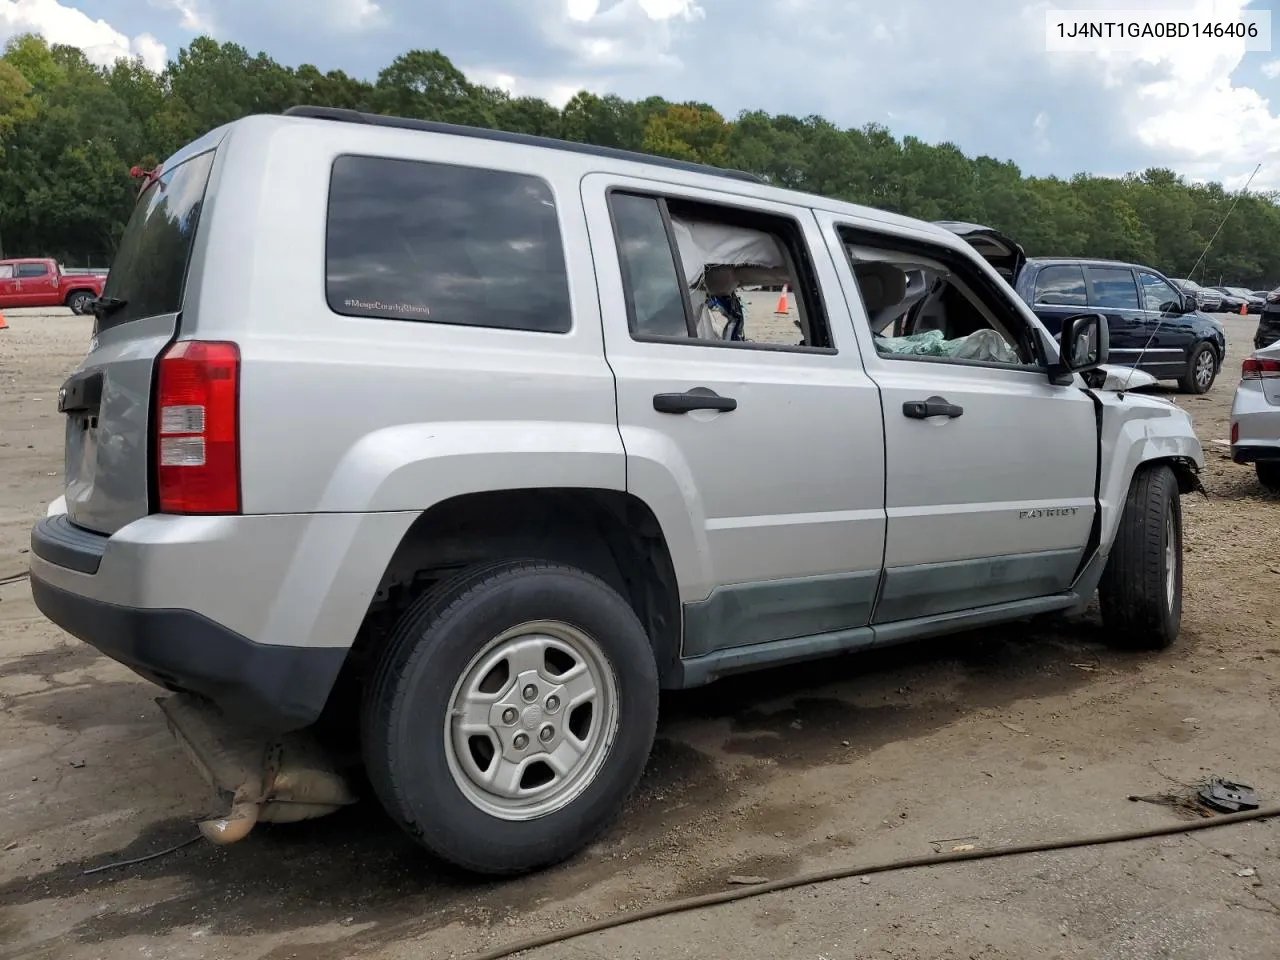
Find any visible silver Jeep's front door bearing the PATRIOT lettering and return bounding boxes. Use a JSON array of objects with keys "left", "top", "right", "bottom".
[{"left": 819, "top": 214, "right": 1098, "bottom": 623}]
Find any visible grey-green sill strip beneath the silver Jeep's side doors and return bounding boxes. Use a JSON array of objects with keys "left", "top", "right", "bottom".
[{"left": 667, "top": 591, "right": 1080, "bottom": 689}]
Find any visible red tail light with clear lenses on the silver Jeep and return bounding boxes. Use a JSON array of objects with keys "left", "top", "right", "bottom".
[{"left": 152, "top": 340, "right": 241, "bottom": 513}]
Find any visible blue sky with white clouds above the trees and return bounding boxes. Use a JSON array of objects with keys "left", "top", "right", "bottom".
[{"left": 0, "top": 0, "right": 1280, "bottom": 189}]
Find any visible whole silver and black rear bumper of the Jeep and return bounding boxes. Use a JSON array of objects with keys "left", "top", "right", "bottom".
[{"left": 31, "top": 504, "right": 416, "bottom": 732}]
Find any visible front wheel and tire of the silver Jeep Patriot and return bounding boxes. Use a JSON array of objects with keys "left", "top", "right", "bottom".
[{"left": 1098, "top": 465, "right": 1183, "bottom": 650}]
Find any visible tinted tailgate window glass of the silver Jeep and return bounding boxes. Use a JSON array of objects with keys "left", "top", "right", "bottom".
[{"left": 99, "top": 151, "right": 214, "bottom": 330}]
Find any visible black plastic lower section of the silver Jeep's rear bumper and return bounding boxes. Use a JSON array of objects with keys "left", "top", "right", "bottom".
[{"left": 31, "top": 570, "right": 347, "bottom": 732}]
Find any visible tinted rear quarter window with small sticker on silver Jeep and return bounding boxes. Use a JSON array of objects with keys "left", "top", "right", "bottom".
[{"left": 325, "top": 156, "right": 572, "bottom": 333}]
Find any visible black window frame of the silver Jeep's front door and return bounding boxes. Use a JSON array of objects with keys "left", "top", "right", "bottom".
[{"left": 835, "top": 221, "right": 1048, "bottom": 374}]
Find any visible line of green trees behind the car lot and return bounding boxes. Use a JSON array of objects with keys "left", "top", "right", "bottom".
[{"left": 0, "top": 35, "right": 1280, "bottom": 289}]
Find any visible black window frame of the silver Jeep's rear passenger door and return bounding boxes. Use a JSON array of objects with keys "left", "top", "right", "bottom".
[{"left": 604, "top": 184, "right": 840, "bottom": 356}]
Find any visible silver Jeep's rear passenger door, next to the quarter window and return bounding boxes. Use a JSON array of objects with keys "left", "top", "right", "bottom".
[{"left": 582, "top": 174, "right": 884, "bottom": 658}]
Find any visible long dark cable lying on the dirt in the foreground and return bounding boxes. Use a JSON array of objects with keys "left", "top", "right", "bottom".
[{"left": 467, "top": 806, "right": 1280, "bottom": 960}]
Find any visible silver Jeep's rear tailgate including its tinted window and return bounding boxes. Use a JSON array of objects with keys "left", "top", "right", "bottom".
[{"left": 59, "top": 150, "right": 214, "bottom": 534}]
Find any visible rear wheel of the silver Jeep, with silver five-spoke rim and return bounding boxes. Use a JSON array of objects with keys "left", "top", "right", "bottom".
[{"left": 362, "top": 561, "right": 658, "bottom": 874}]
